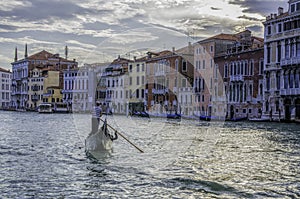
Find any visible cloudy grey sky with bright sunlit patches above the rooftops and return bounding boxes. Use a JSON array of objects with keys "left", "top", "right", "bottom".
[{"left": 0, "top": 0, "right": 288, "bottom": 69}]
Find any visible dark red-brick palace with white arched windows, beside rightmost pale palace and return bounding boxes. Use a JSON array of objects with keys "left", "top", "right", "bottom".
[{"left": 213, "top": 30, "right": 264, "bottom": 119}]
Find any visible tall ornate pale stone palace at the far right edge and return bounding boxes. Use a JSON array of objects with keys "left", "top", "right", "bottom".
[{"left": 263, "top": 0, "right": 300, "bottom": 120}]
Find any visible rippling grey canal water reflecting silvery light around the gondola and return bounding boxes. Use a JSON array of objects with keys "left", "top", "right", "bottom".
[{"left": 0, "top": 111, "right": 300, "bottom": 198}]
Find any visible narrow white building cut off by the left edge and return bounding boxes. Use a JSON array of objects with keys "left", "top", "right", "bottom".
[{"left": 0, "top": 68, "right": 11, "bottom": 109}]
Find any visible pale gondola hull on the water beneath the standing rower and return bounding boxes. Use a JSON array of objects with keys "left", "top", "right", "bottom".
[{"left": 85, "top": 120, "right": 118, "bottom": 152}]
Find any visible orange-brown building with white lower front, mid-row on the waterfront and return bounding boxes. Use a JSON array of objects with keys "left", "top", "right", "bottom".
[{"left": 145, "top": 45, "right": 194, "bottom": 115}]
